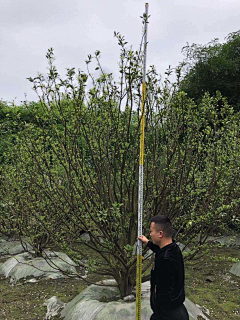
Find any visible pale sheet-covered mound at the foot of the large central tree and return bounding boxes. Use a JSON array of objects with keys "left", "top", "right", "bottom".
[{"left": 61, "top": 280, "right": 208, "bottom": 320}]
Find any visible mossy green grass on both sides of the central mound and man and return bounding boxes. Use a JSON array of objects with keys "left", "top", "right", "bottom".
[{"left": 0, "top": 242, "right": 240, "bottom": 320}]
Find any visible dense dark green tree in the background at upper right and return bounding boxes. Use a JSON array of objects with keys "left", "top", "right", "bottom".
[{"left": 181, "top": 31, "right": 240, "bottom": 110}]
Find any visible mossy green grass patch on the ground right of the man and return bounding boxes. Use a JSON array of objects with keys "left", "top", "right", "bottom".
[{"left": 185, "top": 246, "right": 240, "bottom": 320}]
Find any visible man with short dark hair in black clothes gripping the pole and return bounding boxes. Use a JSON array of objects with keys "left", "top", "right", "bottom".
[{"left": 138, "top": 215, "right": 189, "bottom": 320}]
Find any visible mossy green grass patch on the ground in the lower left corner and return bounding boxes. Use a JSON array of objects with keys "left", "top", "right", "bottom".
[{"left": 0, "top": 270, "right": 105, "bottom": 320}]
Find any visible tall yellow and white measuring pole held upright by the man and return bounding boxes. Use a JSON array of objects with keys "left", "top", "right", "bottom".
[{"left": 136, "top": 3, "right": 148, "bottom": 320}]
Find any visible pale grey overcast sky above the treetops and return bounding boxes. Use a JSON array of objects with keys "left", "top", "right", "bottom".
[{"left": 0, "top": 0, "right": 240, "bottom": 105}]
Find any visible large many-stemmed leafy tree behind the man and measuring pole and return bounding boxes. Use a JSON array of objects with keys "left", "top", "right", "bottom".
[{"left": 2, "top": 33, "right": 239, "bottom": 296}]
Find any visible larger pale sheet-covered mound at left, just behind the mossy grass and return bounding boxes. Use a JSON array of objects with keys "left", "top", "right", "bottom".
[{"left": 0, "top": 252, "right": 77, "bottom": 283}]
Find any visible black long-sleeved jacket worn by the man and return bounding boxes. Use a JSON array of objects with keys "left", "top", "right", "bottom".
[{"left": 147, "top": 241, "right": 185, "bottom": 315}]
